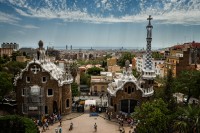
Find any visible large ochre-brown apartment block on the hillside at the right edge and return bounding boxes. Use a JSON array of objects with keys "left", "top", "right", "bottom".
[{"left": 164, "top": 42, "right": 200, "bottom": 77}]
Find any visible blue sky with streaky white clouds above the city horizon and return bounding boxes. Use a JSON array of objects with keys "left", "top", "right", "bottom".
[{"left": 0, "top": 0, "right": 200, "bottom": 48}]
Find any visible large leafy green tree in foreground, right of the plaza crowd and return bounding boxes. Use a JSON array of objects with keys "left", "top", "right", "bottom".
[{"left": 132, "top": 99, "right": 169, "bottom": 133}]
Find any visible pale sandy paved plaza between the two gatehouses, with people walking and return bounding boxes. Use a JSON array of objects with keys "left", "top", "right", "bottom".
[{"left": 40, "top": 113, "right": 133, "bottom": 133}]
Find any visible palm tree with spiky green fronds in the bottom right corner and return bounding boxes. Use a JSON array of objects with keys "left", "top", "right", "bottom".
[{"left": 174, "top": 105, "right": 200, "bottom": 133}]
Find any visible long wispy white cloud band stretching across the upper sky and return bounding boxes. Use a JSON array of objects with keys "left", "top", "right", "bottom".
[{"left": 7, "top": 0, "right": 200, "bottom": 25}]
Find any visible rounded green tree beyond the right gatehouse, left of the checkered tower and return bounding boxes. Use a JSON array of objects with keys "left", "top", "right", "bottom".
[{"left": 118, "top": 52, "right": 134, "bottom": 67}]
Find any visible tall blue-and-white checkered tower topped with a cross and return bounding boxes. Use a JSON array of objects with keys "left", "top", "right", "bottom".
[{"left": 142, "top": 15, "right": 156, "bottom": 92}]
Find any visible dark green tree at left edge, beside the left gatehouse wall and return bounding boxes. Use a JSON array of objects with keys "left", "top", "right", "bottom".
[{"left": 0, "top": 72, "right": 13, "bottom": 98}]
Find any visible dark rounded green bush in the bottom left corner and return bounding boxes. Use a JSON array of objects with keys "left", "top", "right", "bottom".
[{"left": 0, "top": 115, "right": 39, "bottom": 133}]
